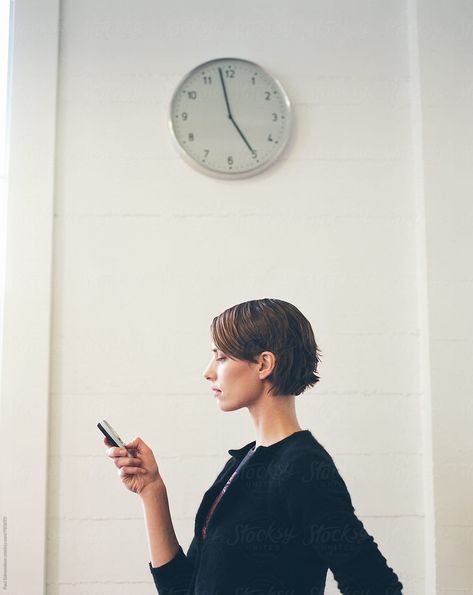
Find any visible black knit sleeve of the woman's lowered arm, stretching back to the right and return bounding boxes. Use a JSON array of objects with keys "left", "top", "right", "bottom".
[{"left": 282, "top": 454, "right": 403, "bottom": 595}]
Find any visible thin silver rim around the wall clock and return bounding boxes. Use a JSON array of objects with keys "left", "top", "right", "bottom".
[{"left": 168, "top": 56, "right": 293, "bottom": 180}]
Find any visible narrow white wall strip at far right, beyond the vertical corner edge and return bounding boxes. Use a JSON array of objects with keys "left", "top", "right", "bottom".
[{"left": 419, "top": 0, "right": 473, "bottom": 595}]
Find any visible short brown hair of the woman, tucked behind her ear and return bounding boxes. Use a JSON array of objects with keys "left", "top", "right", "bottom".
[{"left": 210, "top": 298, "right": 322, "bottom": 396}]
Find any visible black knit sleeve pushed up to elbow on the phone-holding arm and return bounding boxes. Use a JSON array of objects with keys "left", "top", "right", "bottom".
[{"left": 149, "top": 536, "right": 197, "bottom": 595}]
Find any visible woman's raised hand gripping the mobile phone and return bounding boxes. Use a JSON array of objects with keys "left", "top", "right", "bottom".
[{"left": 103, "top": 438, "right": 164, "bottom": 495}]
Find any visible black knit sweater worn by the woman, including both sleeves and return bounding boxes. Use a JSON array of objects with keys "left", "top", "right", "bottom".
[{"left": 149, "top": 430, "right": 403, "bottom": 595}]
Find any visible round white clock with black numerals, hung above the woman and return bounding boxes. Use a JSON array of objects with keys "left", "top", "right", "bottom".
[{"left": 170, "top": 58, "right": 291, "bottom": 178}]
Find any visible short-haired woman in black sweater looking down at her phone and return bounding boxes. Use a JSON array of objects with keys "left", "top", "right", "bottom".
[{"left": 105, "top": 299, "right": 402, "bottom": 595}]
